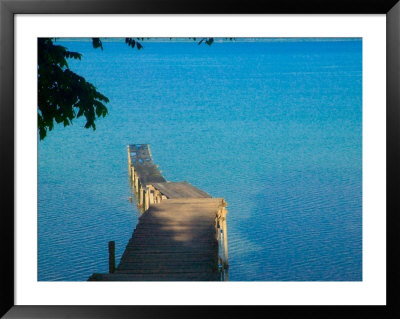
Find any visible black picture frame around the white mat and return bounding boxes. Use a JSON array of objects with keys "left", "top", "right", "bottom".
[{"left": 0, "top": 0, "right": 400, "bottom": 318}]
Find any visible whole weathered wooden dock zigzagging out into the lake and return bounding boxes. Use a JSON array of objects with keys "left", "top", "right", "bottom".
[{"left": 89, "top": 144, "right": 228, "bottom": 281}]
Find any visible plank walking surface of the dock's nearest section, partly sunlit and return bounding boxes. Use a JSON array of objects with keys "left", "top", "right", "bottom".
[{"left": 108, "top": 198, "right": 222, "bottom": 278}]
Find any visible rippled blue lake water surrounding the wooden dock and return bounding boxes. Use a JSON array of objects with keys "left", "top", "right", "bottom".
[{"left": 38, "top": 39, "right": 362, "bottom": 281}]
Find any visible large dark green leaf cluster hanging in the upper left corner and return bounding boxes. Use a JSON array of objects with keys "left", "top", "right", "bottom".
[{"left": 38, "top": 38, "right": 109, "bottom": 140}]
